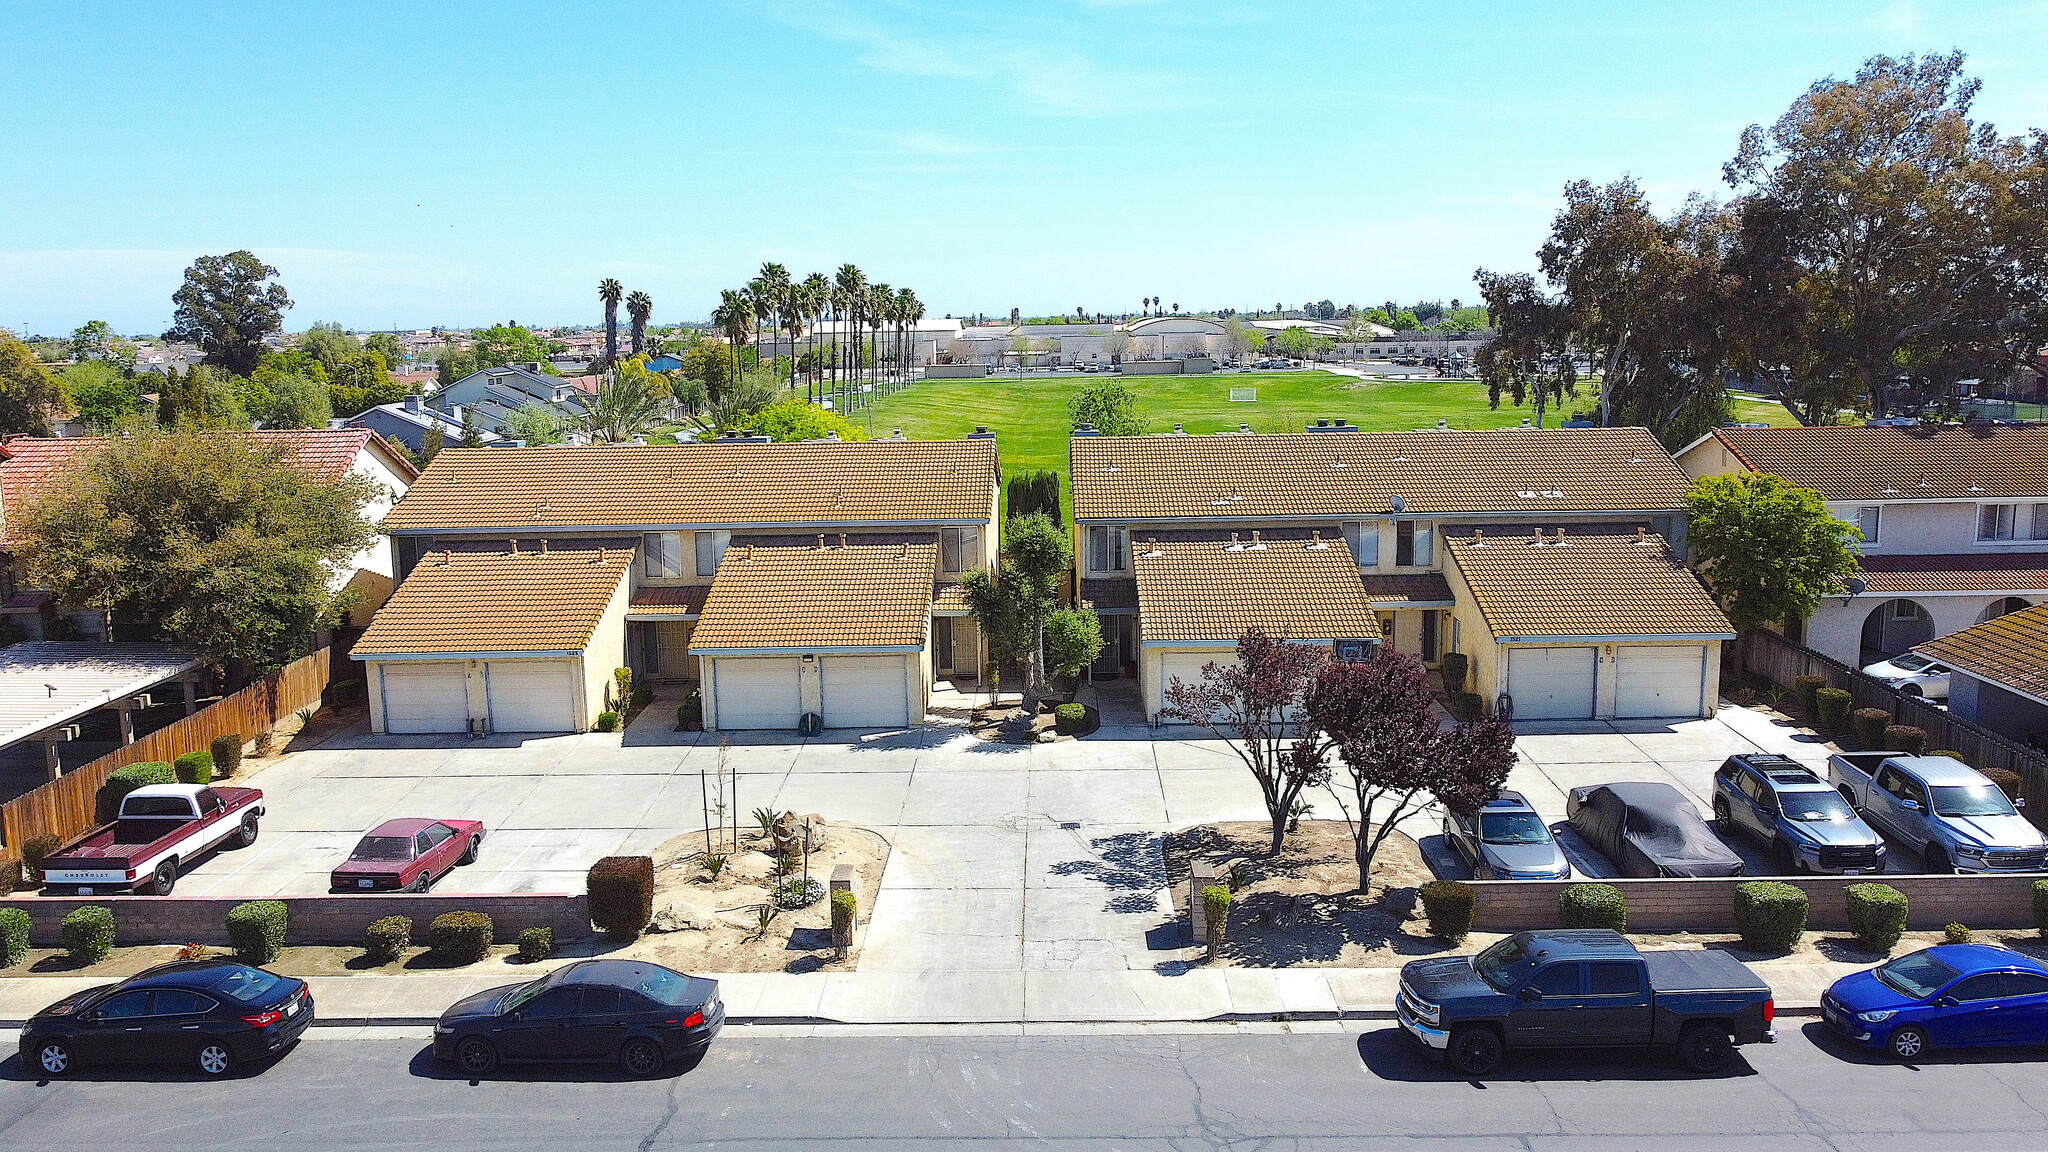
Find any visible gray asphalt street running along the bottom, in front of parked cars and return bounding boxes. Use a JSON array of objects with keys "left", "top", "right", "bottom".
[{"left": 0, "top": 1021, "right": 2048, "bottom": 1152}]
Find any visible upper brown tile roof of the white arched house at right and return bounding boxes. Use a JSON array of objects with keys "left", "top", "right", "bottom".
[{"left": 1712, "top": 424, "right": 2048, "bottom": 500}]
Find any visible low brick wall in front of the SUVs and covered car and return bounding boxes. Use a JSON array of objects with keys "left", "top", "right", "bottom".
[{"left": 1473, "top": 875, "right": 2042, "bottom": 933}]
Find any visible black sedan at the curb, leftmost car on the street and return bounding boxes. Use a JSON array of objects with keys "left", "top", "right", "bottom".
[{"left": 20, "top": 959, "right": 313, "bottom": 1076}]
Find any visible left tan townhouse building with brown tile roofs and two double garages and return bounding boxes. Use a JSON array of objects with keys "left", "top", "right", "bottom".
[{"left": 354, "top": 437, "right": 997, "bottom": 732}]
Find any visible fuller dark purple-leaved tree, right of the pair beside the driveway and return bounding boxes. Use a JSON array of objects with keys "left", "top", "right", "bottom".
[{"left": 1303, "top": 648, "right": 1516, "bottom": 892}]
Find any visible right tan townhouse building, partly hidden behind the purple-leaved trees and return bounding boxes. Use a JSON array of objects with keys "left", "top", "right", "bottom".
[{"left": 1071, "top": 424, "right": 1733, "bottom": 719}]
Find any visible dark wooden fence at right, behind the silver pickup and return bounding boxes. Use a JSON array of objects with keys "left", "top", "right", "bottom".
[{"left": 1735, "top": 631, "right": 2048, "bottom": 828}]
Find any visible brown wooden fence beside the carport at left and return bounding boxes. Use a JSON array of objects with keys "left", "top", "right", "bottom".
[{"left": 0, "top": 648, "right": 330, "bottom": 857}]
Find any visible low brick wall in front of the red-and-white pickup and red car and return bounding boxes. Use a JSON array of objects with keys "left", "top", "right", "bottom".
[{"left": 0, "top": 894, "right": 592, "bottom": 947}]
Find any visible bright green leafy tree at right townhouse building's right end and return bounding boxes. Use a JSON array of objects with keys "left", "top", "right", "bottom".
[{"left": 1686, "top": 474, "right": 1860, "bottom": 627}]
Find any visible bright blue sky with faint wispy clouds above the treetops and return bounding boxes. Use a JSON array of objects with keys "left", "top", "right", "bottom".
[{"left": 0, "top": 0, "right": 2048, "bottom": 332}]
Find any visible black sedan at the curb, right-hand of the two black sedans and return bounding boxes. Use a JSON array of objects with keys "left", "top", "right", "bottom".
[{"left": 434, "top": 959, "right": 725, "bottom": 1076}]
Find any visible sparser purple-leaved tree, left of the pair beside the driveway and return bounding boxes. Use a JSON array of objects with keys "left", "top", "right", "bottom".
[{"left": 1159, "top": 627, "right": 1329, "bottom": 855}]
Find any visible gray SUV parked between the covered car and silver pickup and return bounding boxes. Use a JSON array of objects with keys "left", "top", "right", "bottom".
[{"left": 1714, "top": 754, "right": 1884, "bottom": 875}]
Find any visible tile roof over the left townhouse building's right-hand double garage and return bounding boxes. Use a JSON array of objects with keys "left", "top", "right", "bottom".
[{"left": 690, "top": 537, "right": 938, "bottom": 652}]
